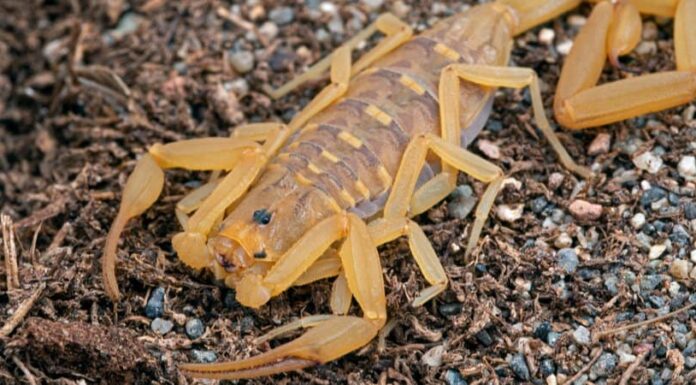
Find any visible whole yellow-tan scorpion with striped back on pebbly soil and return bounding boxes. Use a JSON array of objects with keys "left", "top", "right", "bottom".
[{"left": 102, "top": 0, "right": 696, "bottom": 379}]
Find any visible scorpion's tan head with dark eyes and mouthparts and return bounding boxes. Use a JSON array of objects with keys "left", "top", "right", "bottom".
[{"left": 208, "top": 170, "right": 340, "bottom": 307}]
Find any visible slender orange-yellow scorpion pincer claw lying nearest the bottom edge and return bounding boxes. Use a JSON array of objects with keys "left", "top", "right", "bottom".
[{"left": 179, "top": 316, "right": 379, "bottom": 380}]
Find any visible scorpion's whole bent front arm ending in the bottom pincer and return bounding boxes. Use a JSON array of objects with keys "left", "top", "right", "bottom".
[{"left": 180, "top": 214, "right": 386, "bottom": 379}]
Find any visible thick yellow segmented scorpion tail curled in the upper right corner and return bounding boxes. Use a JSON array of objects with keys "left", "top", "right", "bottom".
[{"left": 554, "top": 0, "right": 696, "bottom": 129}]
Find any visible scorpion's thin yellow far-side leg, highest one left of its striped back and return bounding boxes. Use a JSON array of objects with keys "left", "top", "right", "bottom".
[{"left": 265, "top": 13, "right": 413, "bottom": 99}]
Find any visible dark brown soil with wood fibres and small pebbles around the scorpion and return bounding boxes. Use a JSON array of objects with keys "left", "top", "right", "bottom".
[{"left": 0, "top": 0, "right": 696, "bottom": 385}]
